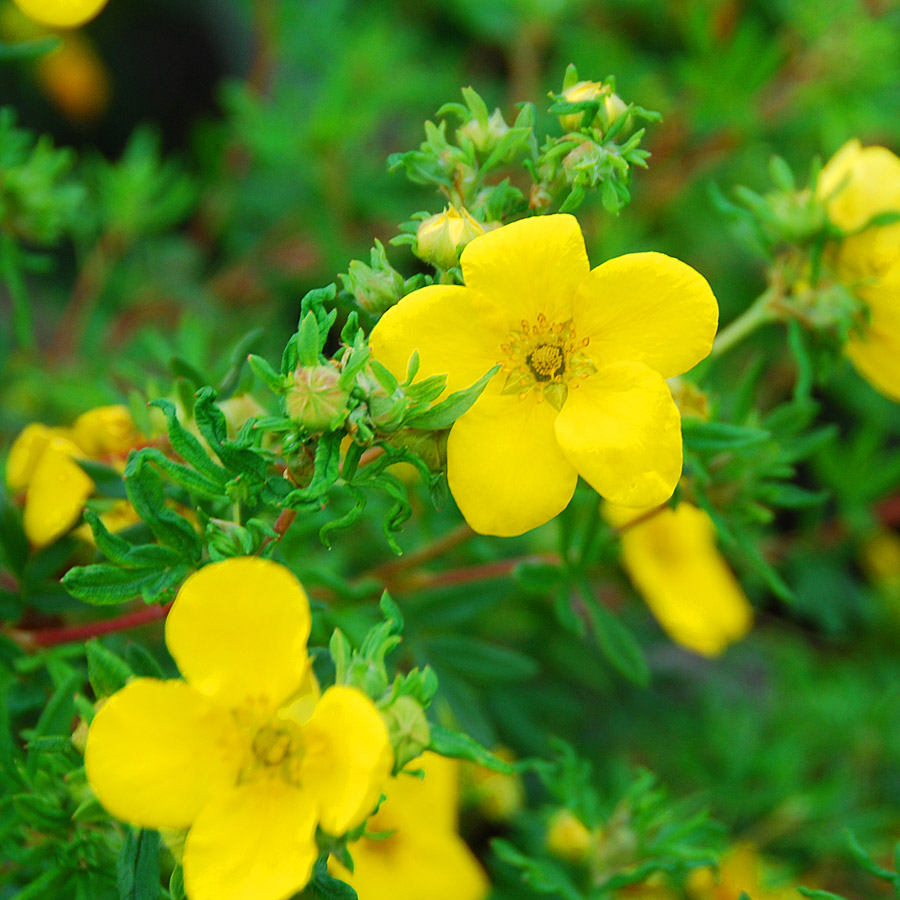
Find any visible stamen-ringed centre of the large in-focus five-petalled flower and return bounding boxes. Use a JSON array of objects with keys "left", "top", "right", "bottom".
[{"left": 499, "top": 313, "right": 597, "bottom": 409}]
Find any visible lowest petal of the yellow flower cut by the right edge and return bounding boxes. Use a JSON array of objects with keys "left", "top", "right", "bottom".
[{"left": 844, "top": 279, "right": 900, "bottom": 401}]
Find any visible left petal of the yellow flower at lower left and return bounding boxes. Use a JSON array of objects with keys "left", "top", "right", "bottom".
[{"left": 84, "top": 678, "right": 246, "bottom": 828}]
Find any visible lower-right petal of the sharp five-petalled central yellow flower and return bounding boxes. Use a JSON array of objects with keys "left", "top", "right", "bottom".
[{"left": 556, "top": 363, "right": 682, "bottom": 506}]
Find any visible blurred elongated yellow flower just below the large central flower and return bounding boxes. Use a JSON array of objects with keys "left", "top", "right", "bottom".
[{"left": 604, "top": 503, "right": 753, "bottom": 656}]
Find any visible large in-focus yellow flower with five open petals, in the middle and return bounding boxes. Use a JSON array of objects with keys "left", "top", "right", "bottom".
[{"left": 371, "top": 215, "right": 718, "bottom": 535}]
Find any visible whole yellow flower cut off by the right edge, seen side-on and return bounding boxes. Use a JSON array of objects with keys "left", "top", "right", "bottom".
[{"left": 817, "top": 140, "right": 900, "bottom": 400}]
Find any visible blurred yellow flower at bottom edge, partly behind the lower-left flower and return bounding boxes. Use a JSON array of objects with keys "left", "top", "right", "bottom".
[{"left": 329, "top": 753, "right": 488, "bottom": 900}]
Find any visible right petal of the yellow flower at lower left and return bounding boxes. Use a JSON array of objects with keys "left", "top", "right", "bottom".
[{"left": 300, "top": 685, "right": 394, "bottom": 835}]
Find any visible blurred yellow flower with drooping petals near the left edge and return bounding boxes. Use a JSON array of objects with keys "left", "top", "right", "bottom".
[{"left": 6, "top": 406, "right": 140, "bottom": 547}]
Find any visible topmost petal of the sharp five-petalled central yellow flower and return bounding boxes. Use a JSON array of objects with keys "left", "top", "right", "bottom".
[{"left": 460, "top": 214, "right": 590, "bottom": 328}]
